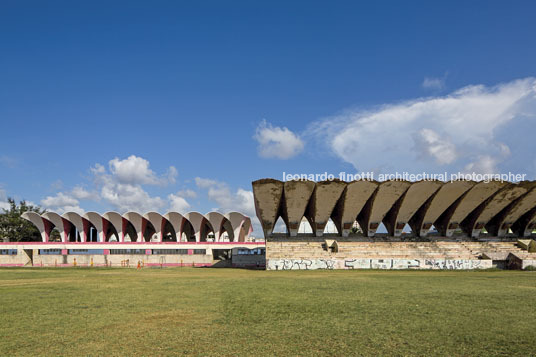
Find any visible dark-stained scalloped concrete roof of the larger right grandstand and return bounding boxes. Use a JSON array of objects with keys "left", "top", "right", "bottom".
[{"left": 252, "top": 179, "right": 536, "bottom": 237}]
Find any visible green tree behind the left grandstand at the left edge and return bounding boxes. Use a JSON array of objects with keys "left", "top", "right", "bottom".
[{"left": 0, "top": 198, "right": 45, "bottom": 242}]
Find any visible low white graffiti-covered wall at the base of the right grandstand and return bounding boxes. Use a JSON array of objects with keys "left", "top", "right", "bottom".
[{"left": 266, "top": 258, "right": 492, "bottom": 270}]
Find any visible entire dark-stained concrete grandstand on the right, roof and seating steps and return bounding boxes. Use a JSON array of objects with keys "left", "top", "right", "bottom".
[{"left": 252, "top": 179, "right": 536, "bottom": 270}]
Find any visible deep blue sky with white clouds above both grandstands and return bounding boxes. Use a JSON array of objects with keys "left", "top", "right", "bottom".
[{"left": 0, "top": 0, "right": 536, "bottom": 235}]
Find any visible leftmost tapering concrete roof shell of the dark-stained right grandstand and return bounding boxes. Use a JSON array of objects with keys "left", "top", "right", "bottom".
[{"left": 251, "top": 179, "right": 288, "bottom": 237}]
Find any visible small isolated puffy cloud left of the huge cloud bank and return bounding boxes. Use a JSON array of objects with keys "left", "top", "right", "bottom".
[{"left": 253, "top": 120, "right": 304, "bottom": 160}]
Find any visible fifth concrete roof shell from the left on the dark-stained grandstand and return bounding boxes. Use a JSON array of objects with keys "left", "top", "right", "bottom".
[{"left": 357, "top": 181, "right": 411, "bottom": 237}]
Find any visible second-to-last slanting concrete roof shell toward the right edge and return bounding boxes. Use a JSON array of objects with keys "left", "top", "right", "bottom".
[{"left": 460, "top": 184, "right": 527, "bottom": 238}]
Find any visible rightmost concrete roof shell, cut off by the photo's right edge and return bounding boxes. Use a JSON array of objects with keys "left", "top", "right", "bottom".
[{"left": 486, "top": 182, "right": 536, "bottom": 237}]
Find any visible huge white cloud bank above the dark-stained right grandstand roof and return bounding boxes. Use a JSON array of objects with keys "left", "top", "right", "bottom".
[{"left": 306, "top": 78, "right": 536, "bottom": 172}]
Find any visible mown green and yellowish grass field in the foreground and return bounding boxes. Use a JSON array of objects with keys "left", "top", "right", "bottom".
[{"left": 0, "top": 268, "right": 536, "bottom": 356}]
